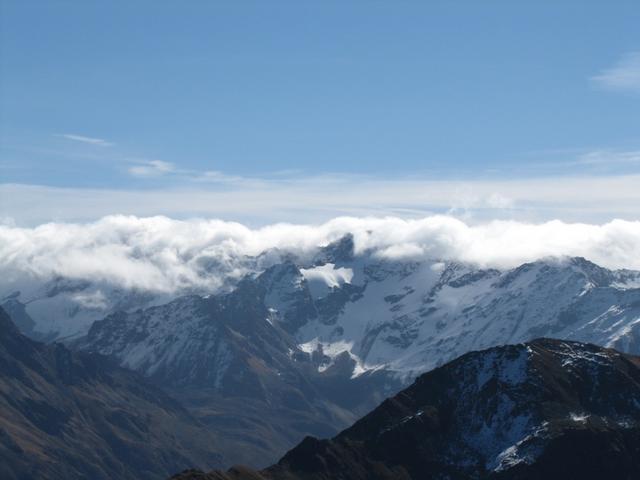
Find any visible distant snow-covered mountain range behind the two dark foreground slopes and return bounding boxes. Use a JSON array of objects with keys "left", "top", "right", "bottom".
[{"left": 4, "top": 236, "right": 640, "bottom": 467}]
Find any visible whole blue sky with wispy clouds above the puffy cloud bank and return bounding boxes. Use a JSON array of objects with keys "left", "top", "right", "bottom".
[{"left": 0, "top": 0, "right": 640, "bottom": 223}]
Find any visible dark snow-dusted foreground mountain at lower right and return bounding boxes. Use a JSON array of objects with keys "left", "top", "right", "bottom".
[{"left": 173, "top": 339, "right": 640, "bottom": 480}]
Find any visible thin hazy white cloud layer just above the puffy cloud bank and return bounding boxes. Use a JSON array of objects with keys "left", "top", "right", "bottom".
[{"left": 0, "top": 175, "right": 640, "bottom": 226}]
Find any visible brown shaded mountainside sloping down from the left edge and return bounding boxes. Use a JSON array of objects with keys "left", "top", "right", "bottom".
[{"left": 0, "top": 309, "right": 222, "bottom": 480}]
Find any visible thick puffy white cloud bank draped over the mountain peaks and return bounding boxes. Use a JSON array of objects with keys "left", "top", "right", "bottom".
[{"left": 0, "top": 215, "right": 640, "bottom": 294}]
